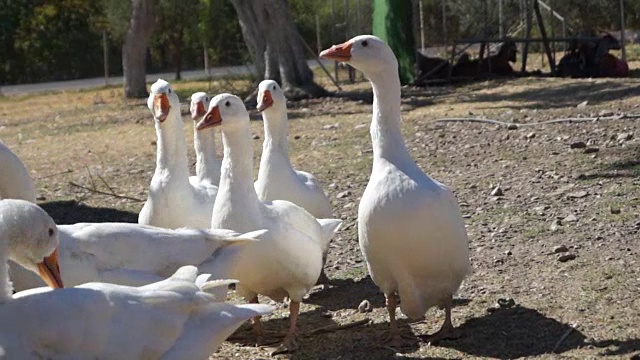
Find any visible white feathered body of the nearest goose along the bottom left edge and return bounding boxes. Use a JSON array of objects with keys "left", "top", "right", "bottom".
[{"left": 0, "top": 266, "right": 270, "bottom": 359}]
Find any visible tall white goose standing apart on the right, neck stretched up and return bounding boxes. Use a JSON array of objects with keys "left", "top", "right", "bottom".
[{"left": 320, "top": 35, "right": 470, "bottom": 343}]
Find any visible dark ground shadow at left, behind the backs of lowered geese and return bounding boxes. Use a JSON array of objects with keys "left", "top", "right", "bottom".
[{"left": 38, "top": 200, "right": 138, "bottom": 225}]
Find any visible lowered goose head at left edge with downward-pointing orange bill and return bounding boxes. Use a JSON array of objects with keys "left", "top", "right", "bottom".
[{"left": 0, "top": 199, "right": 63, "bottom": 288}]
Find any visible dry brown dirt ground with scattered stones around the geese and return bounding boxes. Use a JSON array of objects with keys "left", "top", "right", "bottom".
[{"left": 0, "top": 71, "right": 640, "bottom": 359}]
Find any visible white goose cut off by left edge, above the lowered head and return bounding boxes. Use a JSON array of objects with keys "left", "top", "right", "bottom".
[{"left": 0, "top": 141, "right": 36, "bottom": 203}]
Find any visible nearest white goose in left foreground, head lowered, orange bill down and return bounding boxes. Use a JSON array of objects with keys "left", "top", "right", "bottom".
[{"left": 0, "top": 200, "right": 271, "bottom": 360}]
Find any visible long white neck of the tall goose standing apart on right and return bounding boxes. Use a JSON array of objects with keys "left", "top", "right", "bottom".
[{"left": 369, "top": 69, "right": 414, "bottom": 166}]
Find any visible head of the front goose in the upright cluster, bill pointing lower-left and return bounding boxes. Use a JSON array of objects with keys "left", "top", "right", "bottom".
[{"left": 196, "top": 93, "right": 249, "bottom": 131}]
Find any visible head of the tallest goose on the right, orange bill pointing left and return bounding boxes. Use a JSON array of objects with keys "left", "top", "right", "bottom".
[{"left": 320, "top": 35, "right": 398, "bottom": 77}]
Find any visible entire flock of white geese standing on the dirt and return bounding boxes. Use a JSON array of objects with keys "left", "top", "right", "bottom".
[{"left": 0, "top": 35, "right": 470, "bottom": 359}]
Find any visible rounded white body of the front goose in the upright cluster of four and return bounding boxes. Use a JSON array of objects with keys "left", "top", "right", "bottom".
[{"left": 201, "top": 201, "right": 340, "bottom": 302}]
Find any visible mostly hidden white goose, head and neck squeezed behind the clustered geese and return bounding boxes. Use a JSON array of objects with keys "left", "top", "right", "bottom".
[{"left": 189, "top": 92, "right": 222, "bottom": 186}]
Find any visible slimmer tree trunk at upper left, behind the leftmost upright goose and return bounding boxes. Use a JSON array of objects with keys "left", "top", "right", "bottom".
[{"left": 122, "top": 0, "right": 158, "bottom": 98}]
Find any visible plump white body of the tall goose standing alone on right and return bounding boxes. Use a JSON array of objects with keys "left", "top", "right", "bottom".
[{"left": 358, "top": 159, "right": 470, "bottom": 318}]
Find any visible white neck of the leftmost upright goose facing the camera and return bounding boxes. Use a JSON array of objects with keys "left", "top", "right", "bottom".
[{"left": 154, "top": 106, "right": 189, "bottom": 183}]
